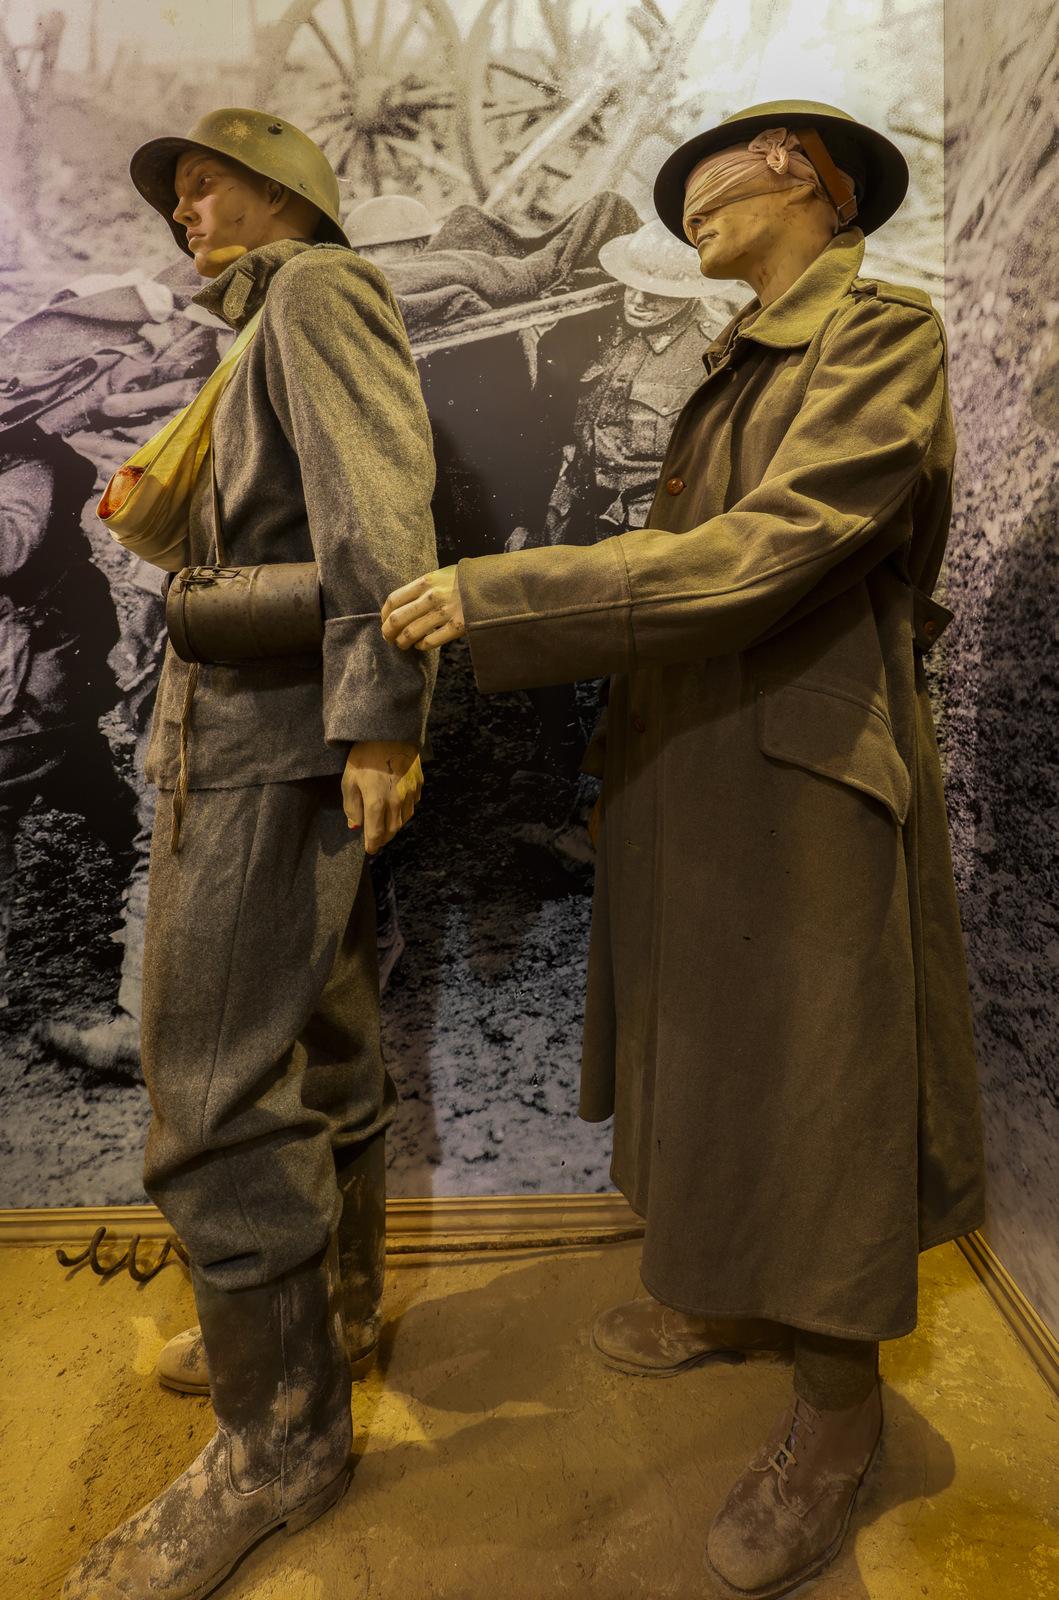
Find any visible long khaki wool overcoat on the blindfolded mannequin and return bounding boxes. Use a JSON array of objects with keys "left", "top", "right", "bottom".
[{"left": 459, "top": 229, "right": 982, "bottom": 1338}]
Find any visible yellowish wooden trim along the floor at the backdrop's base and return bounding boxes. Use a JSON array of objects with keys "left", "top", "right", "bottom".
[{"left": 0, "top": 1194, "right": 1059, "bottom": 1394}]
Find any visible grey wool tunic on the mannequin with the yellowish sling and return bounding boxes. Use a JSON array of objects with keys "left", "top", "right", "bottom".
[{"left": 146, "top": 240, "right": 437, "bottom": 789}]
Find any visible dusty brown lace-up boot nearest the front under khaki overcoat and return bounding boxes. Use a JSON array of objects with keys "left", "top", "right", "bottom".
[{"left": 705, "top": 1384, "right": 883, "bottom": 1600}]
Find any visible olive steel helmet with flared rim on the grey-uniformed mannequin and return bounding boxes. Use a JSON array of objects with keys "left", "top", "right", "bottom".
[{"left": 130, "top": 106, "right": 349, "bottom": 256}]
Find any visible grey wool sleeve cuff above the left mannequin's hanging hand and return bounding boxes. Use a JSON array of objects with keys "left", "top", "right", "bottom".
[{"left": 323, "top": 611, "right": 437, "bottom": 750}]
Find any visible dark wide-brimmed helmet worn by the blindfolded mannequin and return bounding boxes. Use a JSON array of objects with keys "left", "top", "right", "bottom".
[{"left": 654, "top": 101, "right": 909, "bottom": 238}]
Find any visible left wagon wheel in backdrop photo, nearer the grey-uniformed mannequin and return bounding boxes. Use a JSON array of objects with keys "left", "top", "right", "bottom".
[{"left": 256, "top": 0, "right": 467, "bottom": 213}]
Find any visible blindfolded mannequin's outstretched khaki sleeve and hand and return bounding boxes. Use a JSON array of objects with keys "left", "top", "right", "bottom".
[{"left": 387, "top": 299, "right": 945, "bottom": 690}]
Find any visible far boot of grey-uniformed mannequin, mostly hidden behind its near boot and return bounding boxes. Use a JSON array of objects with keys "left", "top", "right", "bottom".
[{"left": 155, "top": 1133, "right": 386, "bottom": 1395}]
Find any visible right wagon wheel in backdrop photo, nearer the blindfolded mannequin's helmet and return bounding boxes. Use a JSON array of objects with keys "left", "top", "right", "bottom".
[{"left": 459, "top": 0, "right": 709, "bottom": 222}]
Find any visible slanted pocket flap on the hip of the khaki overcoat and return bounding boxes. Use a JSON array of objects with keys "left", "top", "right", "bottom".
[{"left": 758, "top": 683, "right": 912, "bottom": 824}]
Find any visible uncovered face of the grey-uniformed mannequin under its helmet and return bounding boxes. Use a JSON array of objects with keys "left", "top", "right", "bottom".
[{"left": 173, "top": 149, "right": 320, "bottom": 278}]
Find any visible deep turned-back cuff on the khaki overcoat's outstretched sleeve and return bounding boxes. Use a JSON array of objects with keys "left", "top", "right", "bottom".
[{"left": 459, "top": 539, "right": 633, "bottom": 694}]
